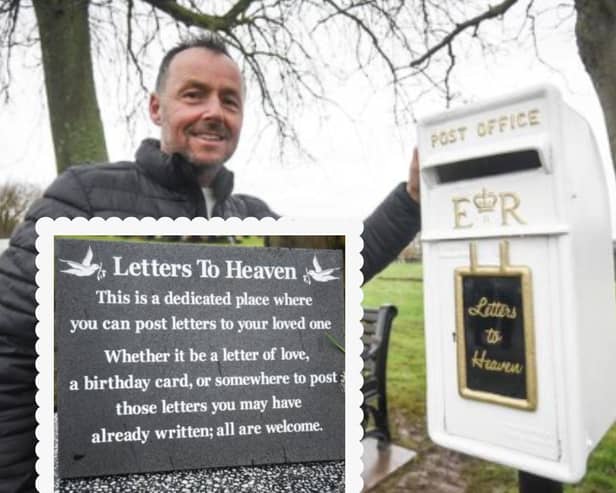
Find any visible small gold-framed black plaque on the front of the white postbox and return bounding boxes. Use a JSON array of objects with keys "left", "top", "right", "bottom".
[{"left": 456, "top": 242, "right": 536, "bottom": 410}]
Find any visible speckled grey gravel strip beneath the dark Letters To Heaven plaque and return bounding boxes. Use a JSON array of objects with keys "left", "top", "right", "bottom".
[{"left": 54, "top": 418, "right": 344, "bottom": 493}]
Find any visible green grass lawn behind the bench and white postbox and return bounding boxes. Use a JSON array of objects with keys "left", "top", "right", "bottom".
[{"left": 363, "top": 263, "right": 616, "bottom": 493}]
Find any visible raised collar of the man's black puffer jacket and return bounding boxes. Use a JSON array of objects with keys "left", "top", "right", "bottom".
[{"left": 135, "top": 139, "right": 234, "bottom": 202}]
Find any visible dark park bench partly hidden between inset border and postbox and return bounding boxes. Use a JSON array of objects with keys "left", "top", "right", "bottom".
[{"left": 362, "top": 305, "right": 398, "bottom": 449}]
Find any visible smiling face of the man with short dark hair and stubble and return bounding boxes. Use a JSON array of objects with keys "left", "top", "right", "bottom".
[{"left": 150, "top": 48, "right": 244, "bottom": 166}]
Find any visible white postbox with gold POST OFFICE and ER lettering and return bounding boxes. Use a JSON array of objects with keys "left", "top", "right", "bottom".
[{"left": 418, "top": 86, "right": 616, "bottom": 482}]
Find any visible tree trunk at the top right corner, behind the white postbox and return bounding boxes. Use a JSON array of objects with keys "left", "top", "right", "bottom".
[{"left": 575, "top": 0, "right": 616, "bottom": 166}]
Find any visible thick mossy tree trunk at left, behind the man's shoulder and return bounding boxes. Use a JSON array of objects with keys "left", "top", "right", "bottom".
[{"left": 33, "top": 0, "right": 107, "bottom": 173}]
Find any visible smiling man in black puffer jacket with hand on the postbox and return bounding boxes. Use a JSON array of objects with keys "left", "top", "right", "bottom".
[{"left": 0, "top": 32, "right": 419, "bottom": 492}]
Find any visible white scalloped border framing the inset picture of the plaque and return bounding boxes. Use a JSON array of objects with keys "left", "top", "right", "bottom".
[{"left": 36, "top": 217, "right": 363, "bottom": 493}]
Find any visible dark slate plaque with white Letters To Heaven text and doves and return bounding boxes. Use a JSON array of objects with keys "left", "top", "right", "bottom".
[{"left": 54, "top": 238, "right": 345, "bottom": 478}]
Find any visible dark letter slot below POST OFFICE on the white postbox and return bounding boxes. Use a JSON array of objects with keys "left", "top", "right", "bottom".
[{"left": 433, "top": 149, "right": 541, "bottom": 183}]
